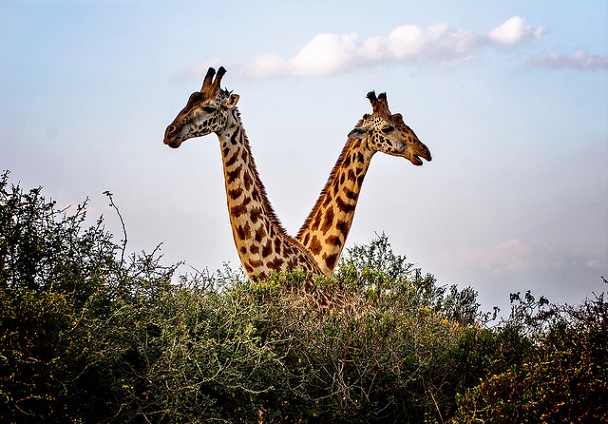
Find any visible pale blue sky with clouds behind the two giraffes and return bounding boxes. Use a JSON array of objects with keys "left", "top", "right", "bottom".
[{"left": 0, "top": 0, "right": 608, "bottom": 311}]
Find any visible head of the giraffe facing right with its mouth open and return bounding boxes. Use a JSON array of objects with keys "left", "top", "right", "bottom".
[{"left": 348, "top": 91, "right": 431, "bottom": 165}]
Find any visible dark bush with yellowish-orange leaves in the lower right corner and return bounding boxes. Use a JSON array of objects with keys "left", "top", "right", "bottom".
[{"left": 453, "top": 286, "right": 608, "bottom": 423}]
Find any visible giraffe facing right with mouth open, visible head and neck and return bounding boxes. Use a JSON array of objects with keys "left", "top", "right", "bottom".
[{"left": 296, "top": 91, "right": 431, "bottom": 274}]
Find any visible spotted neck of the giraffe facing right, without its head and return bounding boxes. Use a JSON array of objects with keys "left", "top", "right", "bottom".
[{"left": 296, "top": 139, "right": 374, "bottom": 274}]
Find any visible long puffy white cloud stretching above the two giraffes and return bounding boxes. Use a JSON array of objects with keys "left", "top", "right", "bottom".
[{"left": 244, "top": 16, "right": 545, "bottom": 78}]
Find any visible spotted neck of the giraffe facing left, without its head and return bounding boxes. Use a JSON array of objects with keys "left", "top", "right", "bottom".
[{"left": 218, "top": 108, "right": 320, "bottom": 278}]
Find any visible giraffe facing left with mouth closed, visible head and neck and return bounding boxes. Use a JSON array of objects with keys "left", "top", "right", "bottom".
[{"left": 164, "top": 67, "right": 321, "bottom": 279}]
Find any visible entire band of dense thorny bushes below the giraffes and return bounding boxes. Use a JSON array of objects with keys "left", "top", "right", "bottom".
[{"left": 0, "top": 173, "right": 608, "bottom": 423}]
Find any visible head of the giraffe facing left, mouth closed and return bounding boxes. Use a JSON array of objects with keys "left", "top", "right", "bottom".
[{"left": 164, "top": 67, "right": 239, "bottom": 148}]
